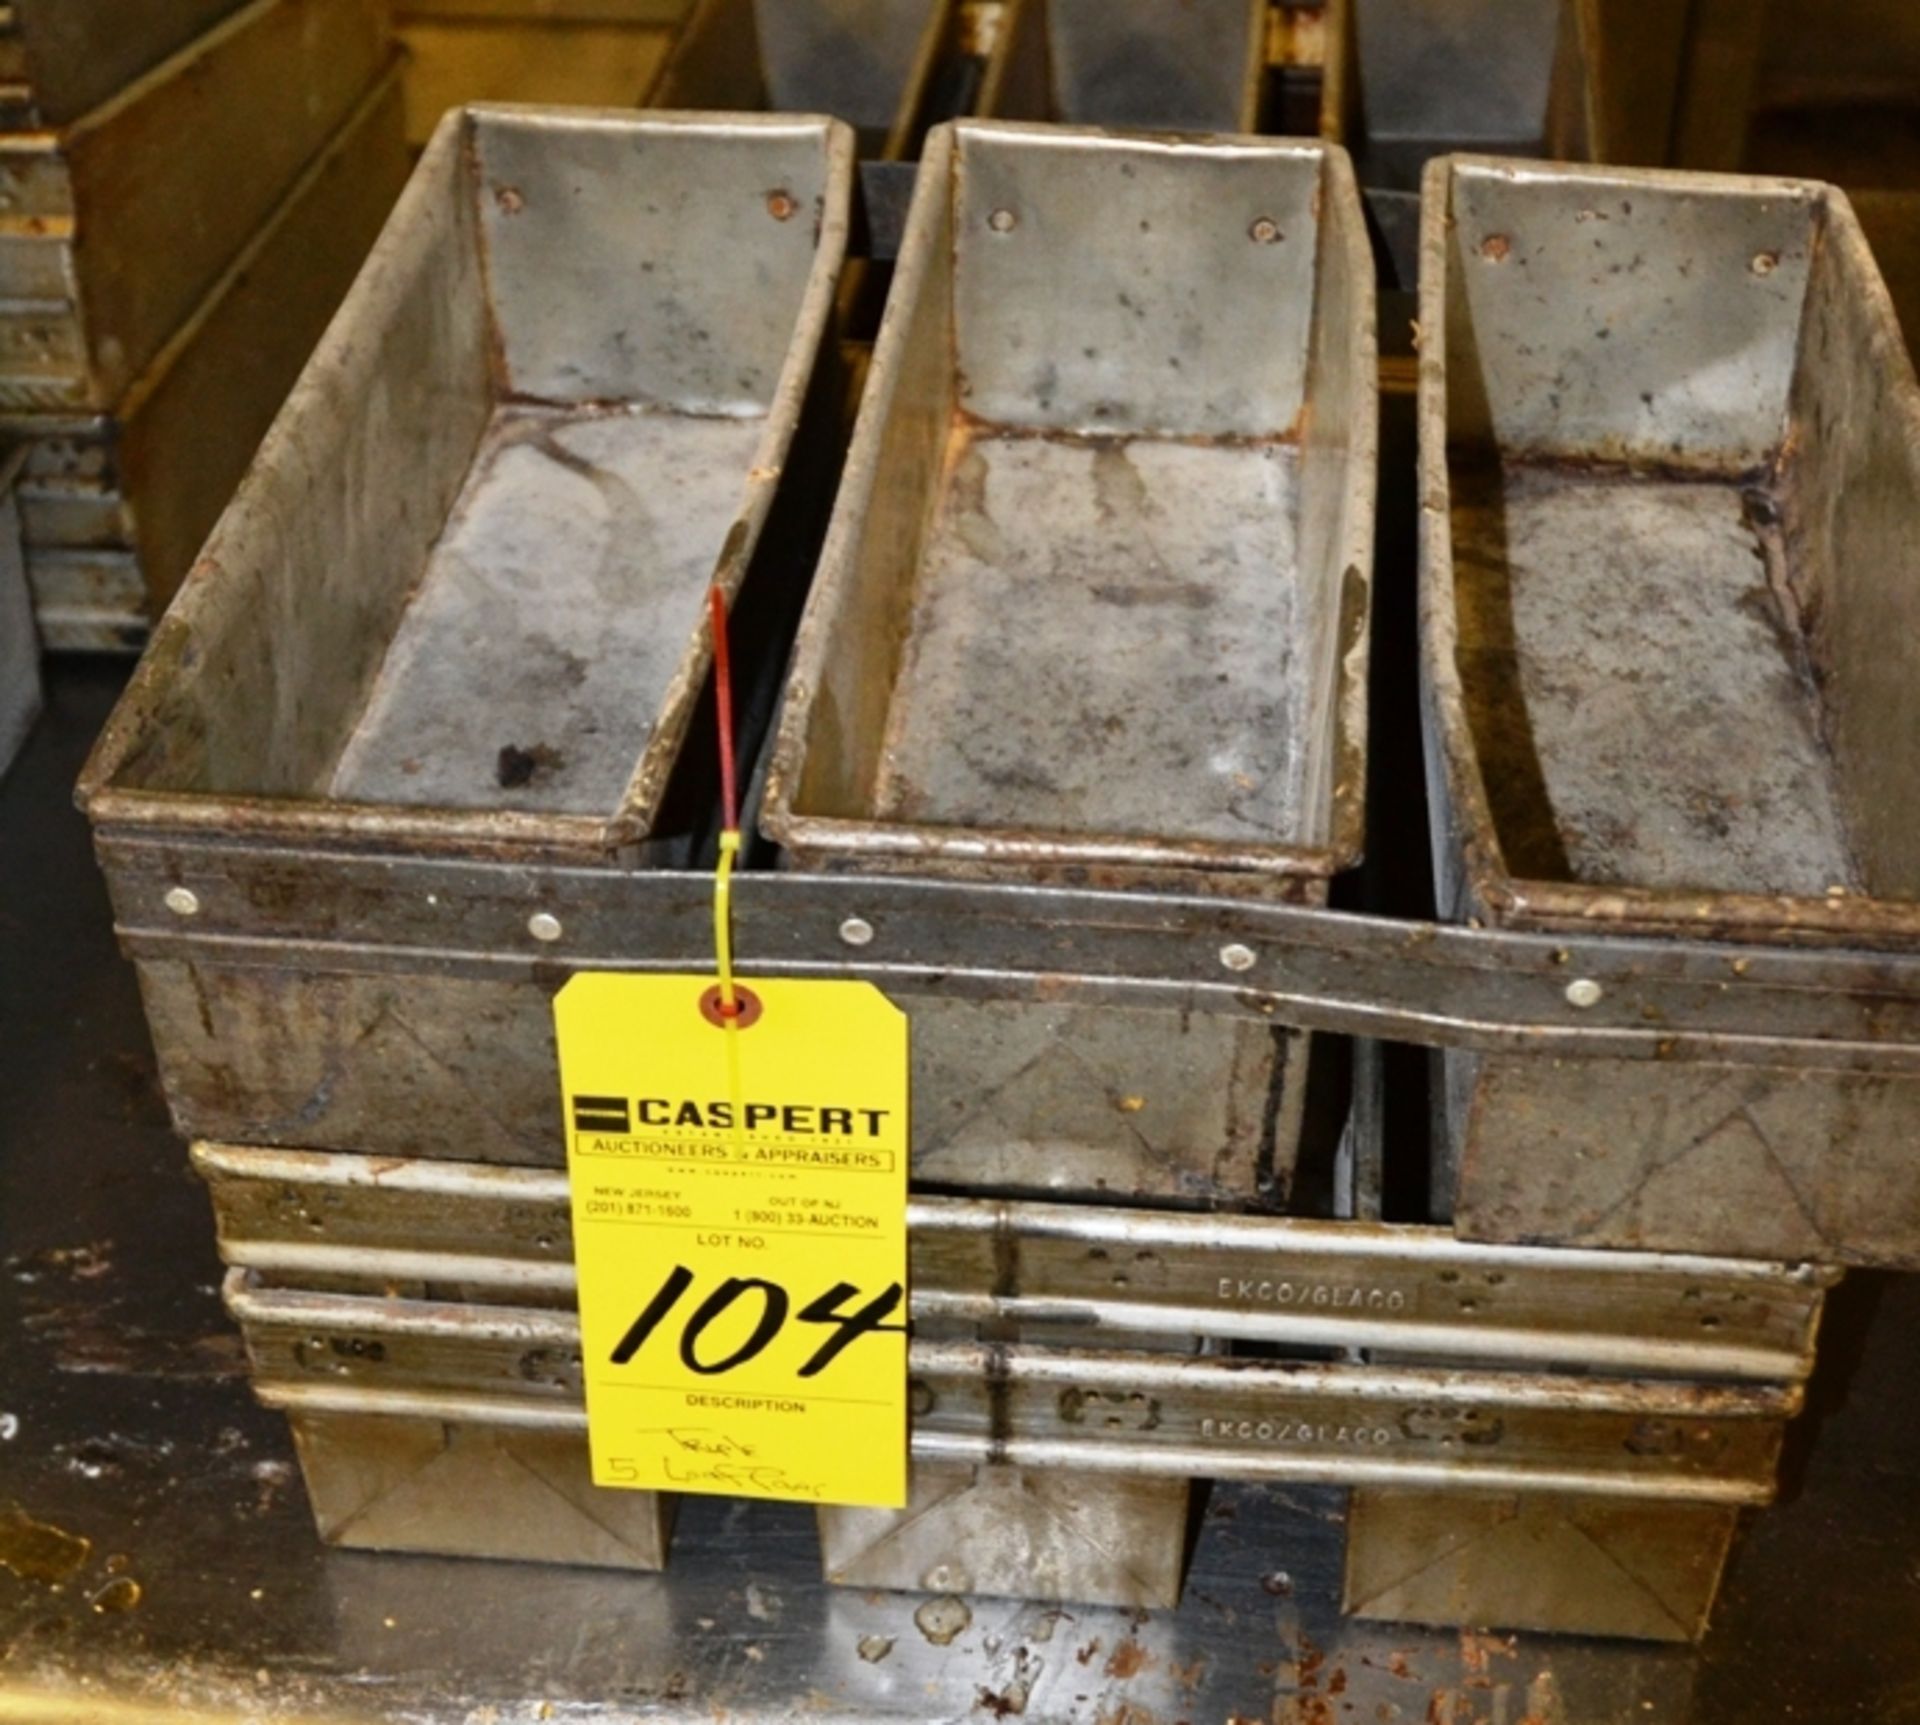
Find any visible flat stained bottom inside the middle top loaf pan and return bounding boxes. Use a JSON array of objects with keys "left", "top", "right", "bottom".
[{"left": 876, "top": 426, "right": 1309, "bottom": 843}]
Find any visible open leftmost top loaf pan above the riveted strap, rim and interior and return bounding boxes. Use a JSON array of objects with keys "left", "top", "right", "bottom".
[{"left": 83, "top": 108, "right": 852, "bottom": 875}]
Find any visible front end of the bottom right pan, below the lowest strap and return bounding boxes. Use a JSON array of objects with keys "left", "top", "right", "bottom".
[{"left": 1344, "top": 1487, "right": 1740, "bottom": 1642}]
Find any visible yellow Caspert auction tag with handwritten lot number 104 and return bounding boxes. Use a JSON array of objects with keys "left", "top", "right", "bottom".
[{"left": 553, "top": 974, "right": 908, "bottom": 1508}]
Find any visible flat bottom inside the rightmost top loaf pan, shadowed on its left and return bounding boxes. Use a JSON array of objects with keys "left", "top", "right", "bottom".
[{"left": 1453, "top": 463, "right": 1860, "bottom": 895}]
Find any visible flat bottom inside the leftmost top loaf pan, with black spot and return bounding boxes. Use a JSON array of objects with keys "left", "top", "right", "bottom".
[{"left": 330, "top": 405, "right": 766, "bottom": 814}]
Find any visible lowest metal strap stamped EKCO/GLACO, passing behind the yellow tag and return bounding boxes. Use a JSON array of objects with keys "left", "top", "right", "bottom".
[{"left": 227, "top": 1270, "right": 1801, "bottom": 1504}]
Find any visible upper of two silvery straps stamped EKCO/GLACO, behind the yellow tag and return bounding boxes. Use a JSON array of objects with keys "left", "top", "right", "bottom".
[{"left": 194, "top": 1145, "right": 1836, "bottom": 1383}]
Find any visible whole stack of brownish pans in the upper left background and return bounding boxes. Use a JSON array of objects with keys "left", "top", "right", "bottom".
[{"left": 0, "top": 0, "right": 405, "bottom": 651}]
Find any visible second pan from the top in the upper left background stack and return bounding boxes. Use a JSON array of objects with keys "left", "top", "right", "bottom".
[{"left": 0, "top": 0, "right": 392, "bottom": 411}]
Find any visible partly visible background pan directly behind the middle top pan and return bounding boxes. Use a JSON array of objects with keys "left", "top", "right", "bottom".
[{"left": 979, "top": 0, "right": 1267, "bottom": 133}]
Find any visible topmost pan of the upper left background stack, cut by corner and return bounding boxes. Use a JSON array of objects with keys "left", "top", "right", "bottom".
[{"left": 0, "top": 0, "right": 251, "bottom": 127}]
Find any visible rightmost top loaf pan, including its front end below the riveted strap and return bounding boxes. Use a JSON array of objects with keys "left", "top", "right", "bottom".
[{"left": 1421, "top": 158, "right": 1920, "bottom": 1268}]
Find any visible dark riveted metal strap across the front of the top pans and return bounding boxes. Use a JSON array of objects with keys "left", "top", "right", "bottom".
[{"left": 96, "top": 829, "right": 1920, "bottom": 1074}]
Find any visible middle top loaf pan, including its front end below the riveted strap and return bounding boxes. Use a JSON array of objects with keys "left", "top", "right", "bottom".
[{"left": 764, "top": 123, "right": 1375, "bottom": 1204}]
